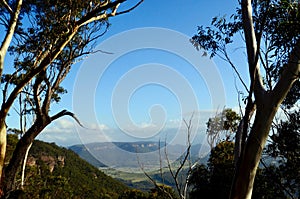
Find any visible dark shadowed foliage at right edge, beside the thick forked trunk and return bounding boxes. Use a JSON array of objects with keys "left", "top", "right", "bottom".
[{"left": 266, "top": 110, "right": 300, "bottom": 198}]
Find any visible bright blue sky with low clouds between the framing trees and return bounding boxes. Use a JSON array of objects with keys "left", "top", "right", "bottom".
[{"left": 4, "top": 0, "right": 248, "bottom": 146}]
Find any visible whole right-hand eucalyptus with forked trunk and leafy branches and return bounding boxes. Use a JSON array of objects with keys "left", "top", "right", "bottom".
[{"left": 192, "top": 0, "right": 300, "bottom": 199}]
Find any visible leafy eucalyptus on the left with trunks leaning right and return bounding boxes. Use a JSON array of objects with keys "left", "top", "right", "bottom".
[{"left": 0, "top": 0, "right": 142, "bottom": 195}]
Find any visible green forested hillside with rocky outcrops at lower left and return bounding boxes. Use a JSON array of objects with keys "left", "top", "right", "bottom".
[{"left": 8, "top": 135, "right": 129, "bottom": 198}]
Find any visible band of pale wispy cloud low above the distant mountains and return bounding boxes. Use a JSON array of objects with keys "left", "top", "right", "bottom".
[{"left": 38, "top": 111, "right": 219, "bottom": 146}]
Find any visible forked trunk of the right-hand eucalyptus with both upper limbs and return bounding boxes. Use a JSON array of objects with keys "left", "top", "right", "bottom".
[{"left": 230, "top": 0, "right": 300, "bottom": 199}]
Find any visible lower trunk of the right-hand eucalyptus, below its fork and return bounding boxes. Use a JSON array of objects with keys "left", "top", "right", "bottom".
[{"left": 231, "top": 94, "right": 279, "bottom": 199}]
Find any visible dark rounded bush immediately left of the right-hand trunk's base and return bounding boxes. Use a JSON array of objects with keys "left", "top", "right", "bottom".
[{"left": 189, "top": 141, "right": 234, "bottom": 198}]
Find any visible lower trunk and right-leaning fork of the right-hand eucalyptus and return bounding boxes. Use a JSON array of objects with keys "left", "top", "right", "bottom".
[{"left": 231, "top": 40, "right": 300, "bottom": 199}]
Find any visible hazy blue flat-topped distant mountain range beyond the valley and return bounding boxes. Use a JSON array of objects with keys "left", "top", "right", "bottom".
[{"left": 69, "top": 141, "right": 208, "bottom": 169}]
